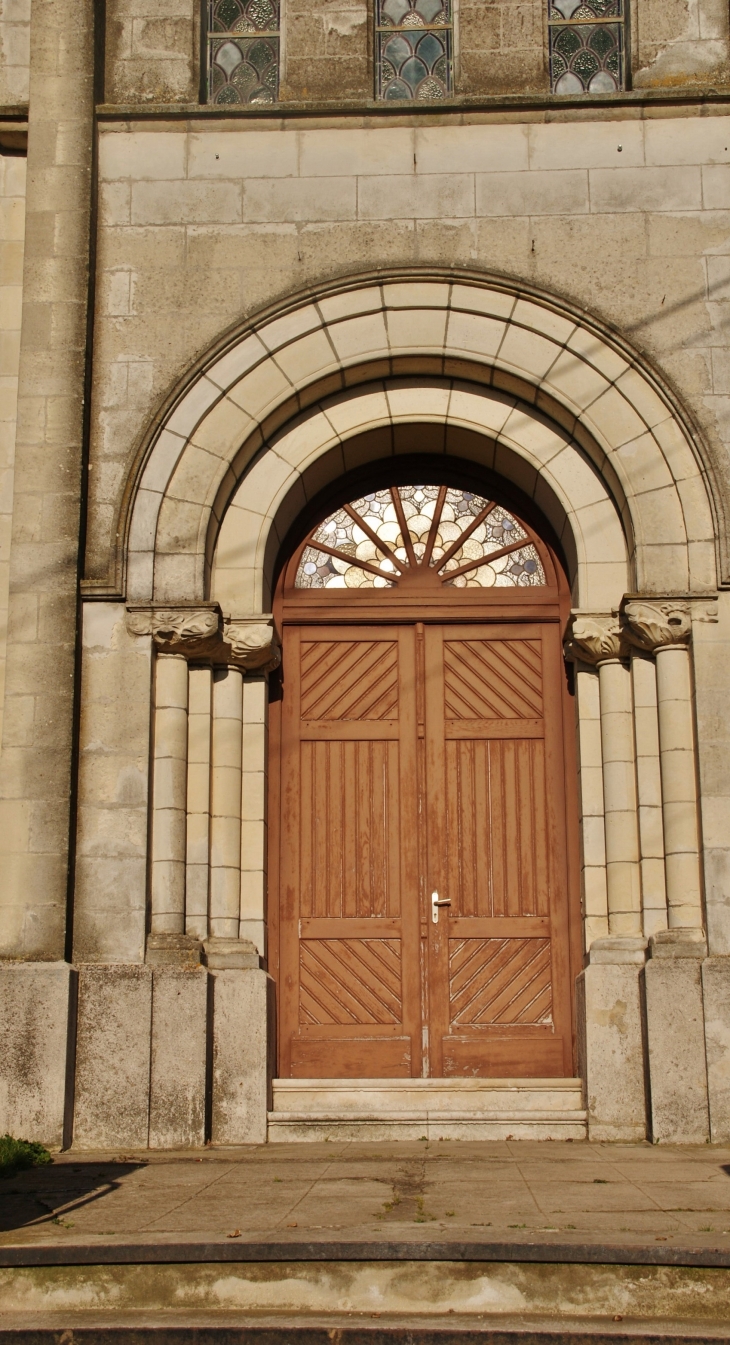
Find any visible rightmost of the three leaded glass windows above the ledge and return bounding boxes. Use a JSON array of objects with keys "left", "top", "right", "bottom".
[{"left": 547, "top": 0, "right": 628, "bottom": 94}]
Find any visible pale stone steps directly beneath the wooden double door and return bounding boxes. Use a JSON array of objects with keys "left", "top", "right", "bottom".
[{"left": 269, "top": 1079, "right": 586, "bottom": 1142}]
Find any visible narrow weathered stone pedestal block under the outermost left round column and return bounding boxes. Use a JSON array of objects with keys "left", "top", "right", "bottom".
[{"left": 149, "top": 966, "right": 208, "bottom": 1149}]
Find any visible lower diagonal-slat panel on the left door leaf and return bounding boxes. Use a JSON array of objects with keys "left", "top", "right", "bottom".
[{"left": 300, "top": 939, "right": 403, "bottom": 1026}]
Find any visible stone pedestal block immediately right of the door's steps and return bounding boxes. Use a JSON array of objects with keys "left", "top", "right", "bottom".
[{"left": 577, "top": 939, "right": 647, "bottom": 1143}]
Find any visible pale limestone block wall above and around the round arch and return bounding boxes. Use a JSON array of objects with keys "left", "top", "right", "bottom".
[{"left": 87, "top": 113, "right": 730, "bottom": 586}]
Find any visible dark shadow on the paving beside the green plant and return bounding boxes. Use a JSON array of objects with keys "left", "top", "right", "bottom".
[{"left": 0, "top": 1158, "right": 145, "bottom": 1233}]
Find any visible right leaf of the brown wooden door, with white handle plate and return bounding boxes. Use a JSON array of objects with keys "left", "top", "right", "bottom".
[{"left": 425, "top": 624, "right": 573, "bottom": 1077}]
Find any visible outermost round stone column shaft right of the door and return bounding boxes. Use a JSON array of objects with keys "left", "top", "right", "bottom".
[{"left": 656, "top": 644, "right": 702, "bottom": 929}]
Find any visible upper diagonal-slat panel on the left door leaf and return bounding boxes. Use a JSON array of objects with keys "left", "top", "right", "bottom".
[{"left": 300, "top": 640, "right": 398, "bottom": 721}]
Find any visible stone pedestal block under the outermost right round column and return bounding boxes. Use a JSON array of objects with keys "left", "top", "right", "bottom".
[{"left": 645, "top": 929, "right": 710, "bottom": 1145}]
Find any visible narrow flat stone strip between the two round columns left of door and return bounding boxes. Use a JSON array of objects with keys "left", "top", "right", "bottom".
[{"left": 186, "top": 668, "right": 212, "bottom": 939}]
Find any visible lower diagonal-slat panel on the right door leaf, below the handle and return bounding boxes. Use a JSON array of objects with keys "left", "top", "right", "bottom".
[{"left": 449, "top": 939, "right": 553, "bottom": 1028}]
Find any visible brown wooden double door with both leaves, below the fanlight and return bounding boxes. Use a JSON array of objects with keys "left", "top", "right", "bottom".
[{"left": 278, "top": 621, "right": 573, "bottom": 1079}]
